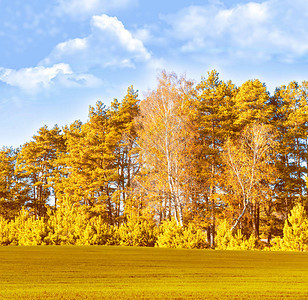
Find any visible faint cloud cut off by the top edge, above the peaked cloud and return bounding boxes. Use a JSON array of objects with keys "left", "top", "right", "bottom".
[{"left": 56, "top": 0, "right": 135, "bottom": 17}]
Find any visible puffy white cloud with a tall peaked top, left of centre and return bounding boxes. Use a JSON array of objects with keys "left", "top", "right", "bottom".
[{"left": 41, "top": 14, "right": 151, "bottom": 71}]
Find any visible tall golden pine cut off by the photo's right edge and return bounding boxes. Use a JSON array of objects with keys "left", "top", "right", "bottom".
[{"left": 271, "top": 82, "right": 308, "bottom": 223}]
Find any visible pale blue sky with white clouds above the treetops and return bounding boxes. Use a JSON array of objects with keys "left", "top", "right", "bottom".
[{"left": 0, "top": 0, "right": 308, "bottom": 147}]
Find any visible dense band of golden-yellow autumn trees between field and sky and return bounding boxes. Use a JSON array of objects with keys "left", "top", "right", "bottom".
[{"left": 0, "top": 71, "right": 308, "bottom": 250}]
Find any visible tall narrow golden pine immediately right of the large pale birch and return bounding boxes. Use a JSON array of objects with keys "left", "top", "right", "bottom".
[{"left": 192, "top": 70, "right": 237, "bottom": 246}]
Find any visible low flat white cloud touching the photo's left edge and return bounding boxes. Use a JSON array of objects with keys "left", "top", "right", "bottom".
[{"left": 0, "top": 63, "right": 100, "bottom": 93}]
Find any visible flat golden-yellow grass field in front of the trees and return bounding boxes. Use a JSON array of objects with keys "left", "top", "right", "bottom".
[{"left": 0, "top": 246, "right": 308, "bottom": 299}]
